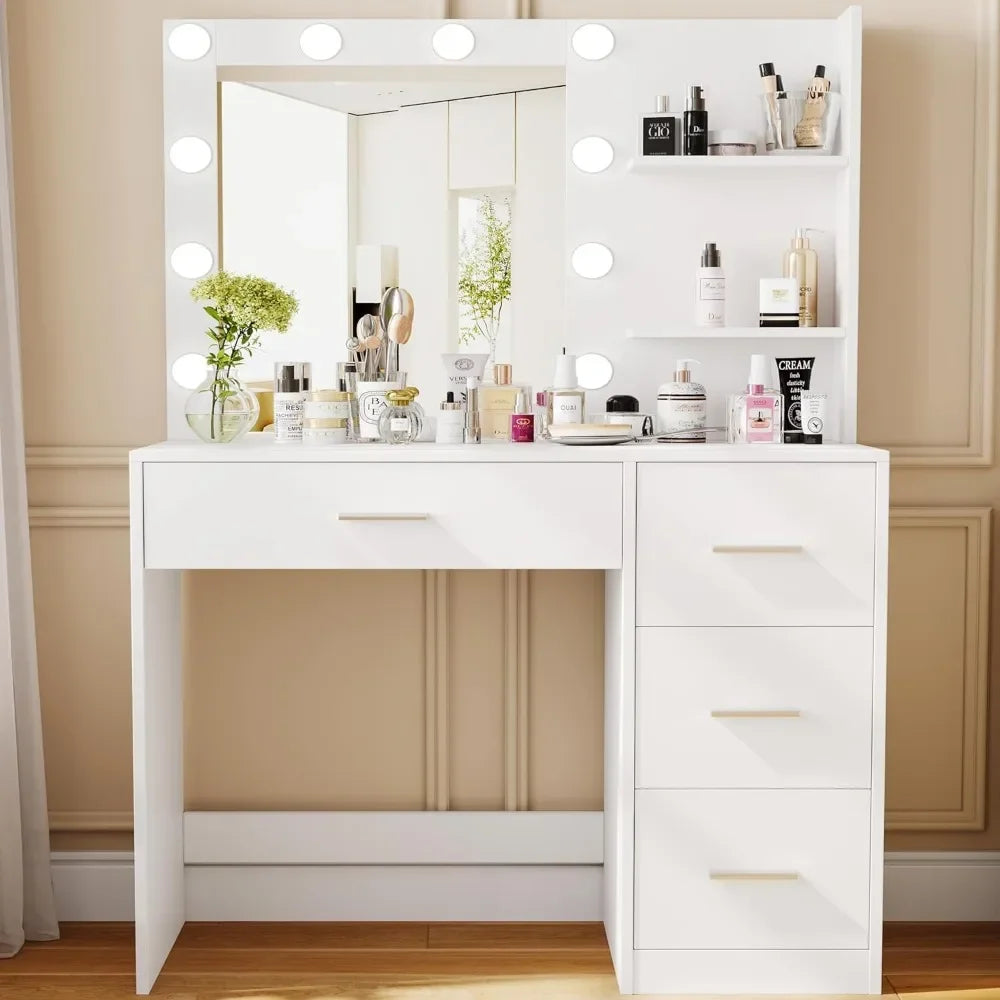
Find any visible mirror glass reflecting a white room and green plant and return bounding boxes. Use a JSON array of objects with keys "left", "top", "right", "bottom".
[{"left": 219, "top": 69, "right": 566, "bottom": 409}]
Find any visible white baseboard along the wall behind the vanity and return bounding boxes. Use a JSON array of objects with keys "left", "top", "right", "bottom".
[{"left": 52, "top": 851, "right": 1000, "bottom": 920}]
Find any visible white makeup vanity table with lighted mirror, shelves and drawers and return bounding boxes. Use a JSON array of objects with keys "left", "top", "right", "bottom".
[{"left": 137, "top": 8, "right": 889, "bottom": 994}]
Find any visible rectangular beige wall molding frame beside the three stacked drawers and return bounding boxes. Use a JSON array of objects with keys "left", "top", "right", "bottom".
[{"left": 885, "top": 507, "right": 992, "bottom": 831}]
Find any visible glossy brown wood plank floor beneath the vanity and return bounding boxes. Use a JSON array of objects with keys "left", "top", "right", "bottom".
[{"left": 0, "top": 923, "right": 1000, "bottom": 1000}]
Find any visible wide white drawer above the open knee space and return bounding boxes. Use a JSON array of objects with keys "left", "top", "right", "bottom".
[{"left": 143, "top": 462, "right": 622, "bottom": 569}]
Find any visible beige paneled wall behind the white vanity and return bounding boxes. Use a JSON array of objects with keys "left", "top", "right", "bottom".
[{"left": 7, "top": 0, "right": 1000, "bottom": 850}]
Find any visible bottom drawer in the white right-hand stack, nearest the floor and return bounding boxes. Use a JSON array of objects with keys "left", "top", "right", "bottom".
[{"left": 635, "top": 790, "right": 870, "bottom": 950}]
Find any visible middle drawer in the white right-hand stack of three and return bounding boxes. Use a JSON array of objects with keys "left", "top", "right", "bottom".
[{"left": 636, "top": 628, "right": 873, "bottom": 788}]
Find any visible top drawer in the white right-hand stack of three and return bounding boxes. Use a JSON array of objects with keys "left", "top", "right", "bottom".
[{"left": 636, "top": 462, "right": 876, "bottom": 625}]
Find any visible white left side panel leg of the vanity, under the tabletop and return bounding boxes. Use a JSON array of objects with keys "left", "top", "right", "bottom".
[{"left": 132, "top": 564, "right": 184, "bottom": 995}]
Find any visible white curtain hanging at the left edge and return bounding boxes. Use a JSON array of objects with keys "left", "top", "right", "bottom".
[{"left": 0, "top": 6, "right": 59, "bottom": 958}]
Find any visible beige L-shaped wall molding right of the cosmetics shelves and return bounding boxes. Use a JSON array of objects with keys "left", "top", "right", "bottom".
[{"left": 865, "top": 0, "right": 1000, "bottom": 468}]
